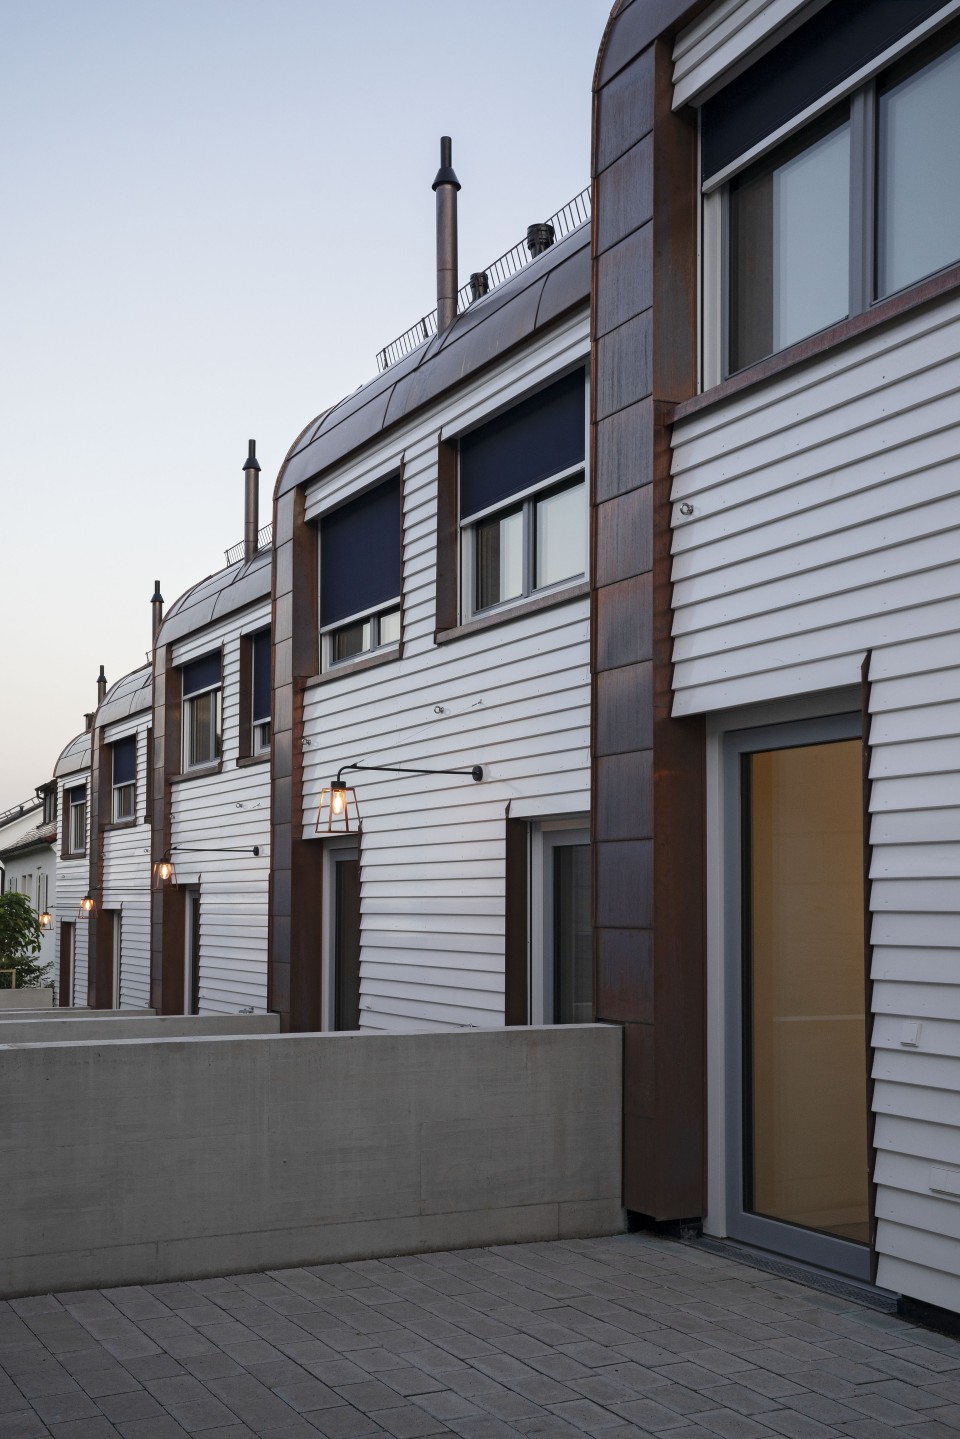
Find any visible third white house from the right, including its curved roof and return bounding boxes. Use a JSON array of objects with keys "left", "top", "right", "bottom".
[{"left": 153, "top": 547, "right": 272, "bottom": 1014}]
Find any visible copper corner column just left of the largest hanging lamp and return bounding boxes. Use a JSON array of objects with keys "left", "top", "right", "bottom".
[{"left": 266, "top": 482, "right": 324, "bottom": 1030}]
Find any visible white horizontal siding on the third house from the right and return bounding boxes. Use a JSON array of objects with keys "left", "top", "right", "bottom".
[{"left": 170, "top": 600, "right": 271, "bottom": 1014}]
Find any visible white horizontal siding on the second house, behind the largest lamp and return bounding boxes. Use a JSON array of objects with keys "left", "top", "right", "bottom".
[{"left": 304, "top": 315, "right": 590, "bottom": 1032}]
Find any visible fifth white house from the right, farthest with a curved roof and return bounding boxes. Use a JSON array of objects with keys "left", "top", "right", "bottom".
[{"left": 53, "top": 730, "right": 91, "bottom": 1006}]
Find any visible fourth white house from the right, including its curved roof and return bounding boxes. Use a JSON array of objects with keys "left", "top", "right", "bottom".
[{"left": 91, "top": 665, "right": 153, "bottom": 1009}]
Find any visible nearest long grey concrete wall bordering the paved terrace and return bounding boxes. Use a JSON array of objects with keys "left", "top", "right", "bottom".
[{"left": 0, "top": 1025, "right": 623, "bottom": 1297}]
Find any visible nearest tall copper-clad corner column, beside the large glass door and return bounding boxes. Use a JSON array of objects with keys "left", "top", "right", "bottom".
[{"left": 592, "top": 14, "right": 707, "bottom": 1220}]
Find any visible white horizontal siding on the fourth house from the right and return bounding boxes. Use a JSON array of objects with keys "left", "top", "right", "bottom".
[{"left": 101, "top": 709, "right": 153, "bottom": 1009}]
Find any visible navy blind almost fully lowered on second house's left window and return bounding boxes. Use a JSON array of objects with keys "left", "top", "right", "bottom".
[{"left": 320, "top": 476, "right": 400, "bottom": 625}]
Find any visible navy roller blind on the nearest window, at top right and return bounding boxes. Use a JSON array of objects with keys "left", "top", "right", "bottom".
[{"left": 701, "top": 0, "right": 943, "bottom": 180}]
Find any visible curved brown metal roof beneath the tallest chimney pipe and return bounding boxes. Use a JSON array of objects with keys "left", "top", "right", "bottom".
[{"left": 275, "top": 224, "right": 590, "bottom": 496}]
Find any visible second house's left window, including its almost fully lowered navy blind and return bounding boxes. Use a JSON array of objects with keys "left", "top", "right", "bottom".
[{"left": 320, "top": 475, "right": 402, "bottom": 669}]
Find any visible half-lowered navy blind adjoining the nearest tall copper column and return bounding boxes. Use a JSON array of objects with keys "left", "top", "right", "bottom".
[{"left": 461, "top": 370, "right": 587, "bottom": 519}]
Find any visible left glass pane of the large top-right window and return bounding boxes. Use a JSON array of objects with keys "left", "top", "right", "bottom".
[{"left": 730, "top": 121, "right": 851, "bottom": 371}]
